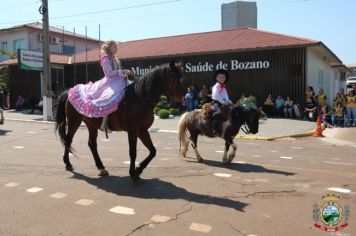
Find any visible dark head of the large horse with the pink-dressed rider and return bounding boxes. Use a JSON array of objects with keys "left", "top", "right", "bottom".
[{"left": 165, "top": 61, "right": 183, "bottom": 103}]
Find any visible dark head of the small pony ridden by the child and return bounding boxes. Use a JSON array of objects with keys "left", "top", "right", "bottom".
[{"left": 232, "top": 106, "right": 261, "bottom": 134}]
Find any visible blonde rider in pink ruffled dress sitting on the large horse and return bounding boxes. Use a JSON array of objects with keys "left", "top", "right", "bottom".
[{"left": 68, "top": 40, "right": 133, "bottom": 132}]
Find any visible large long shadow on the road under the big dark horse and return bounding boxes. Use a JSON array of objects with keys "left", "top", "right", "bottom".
[{"left": 72, "top": 172, "right": 248, "bottom": 212}]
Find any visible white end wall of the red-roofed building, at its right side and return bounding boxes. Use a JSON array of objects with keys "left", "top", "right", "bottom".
[{"left": 307, "top": 47, "right": 342, "bottom": 105}]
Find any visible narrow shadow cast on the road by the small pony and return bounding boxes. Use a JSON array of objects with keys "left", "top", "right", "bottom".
[{"left": 186, "top": 159, "right": 295, "bottom": 176}]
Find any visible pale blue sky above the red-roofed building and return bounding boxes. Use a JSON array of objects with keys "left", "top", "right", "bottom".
[{"left": 0, "top": 0, "right": 356, "bottom": 64}]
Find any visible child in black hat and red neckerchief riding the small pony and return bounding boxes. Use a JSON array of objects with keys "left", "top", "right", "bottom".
[{"left": 211, "top": 69, "right": 233, "bottom": 136}]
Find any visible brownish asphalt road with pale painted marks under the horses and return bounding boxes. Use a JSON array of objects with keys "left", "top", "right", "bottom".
[{"left": 0, "top": 121, "right": 356, "bottom": 236}]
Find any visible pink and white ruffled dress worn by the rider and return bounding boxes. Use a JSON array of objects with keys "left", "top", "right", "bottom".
[{"left": 68, "top": 56, "right": 127, "bottom": 117}]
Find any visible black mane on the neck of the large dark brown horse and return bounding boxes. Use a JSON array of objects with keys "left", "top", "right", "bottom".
[{"left": 133, "top": 64, "right": 169, "bottom": 103}]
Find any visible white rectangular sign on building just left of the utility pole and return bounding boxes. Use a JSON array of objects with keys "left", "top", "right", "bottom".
[{"left": 18, "top": 49, "right": 43, "bottom": 71}]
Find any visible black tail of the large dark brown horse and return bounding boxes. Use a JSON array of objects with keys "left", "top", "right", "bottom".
[{"left": 55, "top": 91, "right": 68, "bottom": 146}]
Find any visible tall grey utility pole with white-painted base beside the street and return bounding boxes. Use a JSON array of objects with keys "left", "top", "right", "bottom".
[{"left": 39, "top": 0, "right": 53, "bottom": 121}]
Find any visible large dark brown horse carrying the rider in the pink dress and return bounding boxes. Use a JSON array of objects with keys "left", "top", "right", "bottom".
[{"left": 56, "top": 62, "right": 182, "bottom": 180}]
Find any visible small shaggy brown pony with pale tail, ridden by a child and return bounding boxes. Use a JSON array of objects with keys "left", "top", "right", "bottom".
[{"left": 178, "top": 103, "right": 260, "bottom": 163}]
